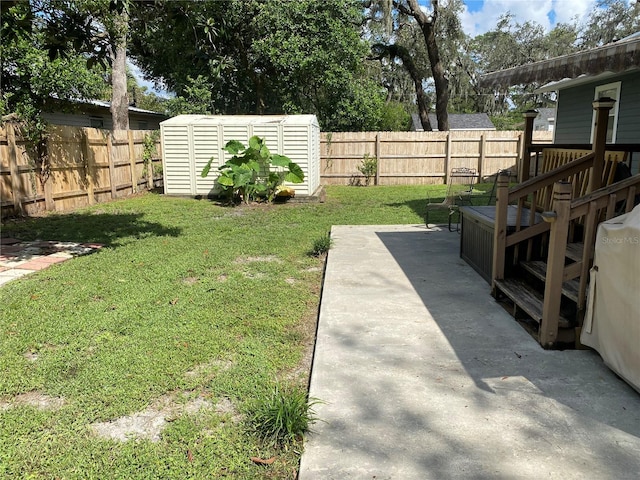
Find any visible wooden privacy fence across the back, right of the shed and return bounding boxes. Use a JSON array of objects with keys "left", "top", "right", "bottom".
[{"left": 320, "top": 130, "right": 553, "bottom": 185}]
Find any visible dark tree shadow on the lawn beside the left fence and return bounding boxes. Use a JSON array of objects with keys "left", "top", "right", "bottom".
[{"left": 2, "top": 213, "right": 182, "bottom": 246}]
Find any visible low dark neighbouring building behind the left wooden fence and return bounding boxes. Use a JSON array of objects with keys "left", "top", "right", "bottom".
[{"left": 42, "top": 100, "right": 169, "bottom": 130}]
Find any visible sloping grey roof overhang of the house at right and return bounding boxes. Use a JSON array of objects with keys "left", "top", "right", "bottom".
[{"left": 479, "top": 32, "right": 640, "bottom": 88}]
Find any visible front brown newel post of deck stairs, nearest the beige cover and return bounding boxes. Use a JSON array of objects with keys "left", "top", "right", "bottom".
[{"left": 539, "top": 182, "right": 572, "bottom": 348}]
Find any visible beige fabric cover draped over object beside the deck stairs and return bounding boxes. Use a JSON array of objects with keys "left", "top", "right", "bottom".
[{"left": 580, "top": 206, "right": 640, "bottom": 391}]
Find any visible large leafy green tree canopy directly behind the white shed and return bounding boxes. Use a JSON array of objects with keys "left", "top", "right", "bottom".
[{"left": 130, "top": 0, "right": 384, "bottom": 131}]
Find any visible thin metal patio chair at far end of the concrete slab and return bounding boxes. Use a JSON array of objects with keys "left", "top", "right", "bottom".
[{"left": 424, "top": 167, "right": 478, "bottom": 232}]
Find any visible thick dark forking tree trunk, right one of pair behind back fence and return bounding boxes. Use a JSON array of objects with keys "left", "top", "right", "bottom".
[{"left": 408, "top": 0, "right": 449, "bottom": 131}]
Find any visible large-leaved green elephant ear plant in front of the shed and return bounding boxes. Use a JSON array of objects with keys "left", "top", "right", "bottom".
[{"left": 200, "top": 136, "right": 304, "bottom": 203}]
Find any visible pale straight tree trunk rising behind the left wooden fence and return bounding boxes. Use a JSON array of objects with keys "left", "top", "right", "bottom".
[{"left": 111, "top": 12, "right": 129, "bottom": 130}]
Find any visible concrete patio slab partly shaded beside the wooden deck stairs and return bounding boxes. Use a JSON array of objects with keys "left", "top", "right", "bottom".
[{"left": 300, "top": 225, "right": 640, "bottom": 480}]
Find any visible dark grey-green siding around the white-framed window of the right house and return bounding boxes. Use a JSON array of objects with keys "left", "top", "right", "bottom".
[{"left": 555, "top": 72, "right": 640, "bottom": 143}]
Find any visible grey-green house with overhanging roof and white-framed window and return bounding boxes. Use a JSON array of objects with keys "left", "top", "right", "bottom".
[{"left": 480, "top": 32, "right": 640, "bottom": 148}]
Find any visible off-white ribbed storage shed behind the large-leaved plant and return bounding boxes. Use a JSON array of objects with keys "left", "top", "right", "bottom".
[{"left": 160, "top": 115, "right": 320, "bottom": 196}]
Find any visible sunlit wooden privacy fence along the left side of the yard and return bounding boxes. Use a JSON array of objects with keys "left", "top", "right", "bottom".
[{"left": 0, "top": 123, "right": 161, "bottom": 217}]
